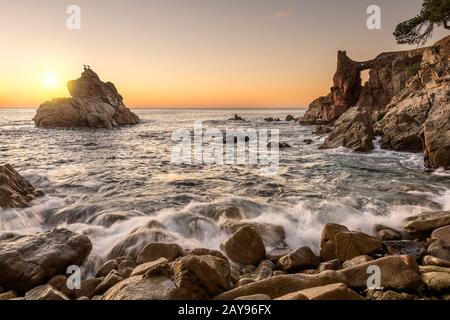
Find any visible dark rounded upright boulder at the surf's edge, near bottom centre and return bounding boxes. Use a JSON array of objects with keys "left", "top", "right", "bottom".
[{"left": 221, "top": 226, "right": 266, "bottom": 265}]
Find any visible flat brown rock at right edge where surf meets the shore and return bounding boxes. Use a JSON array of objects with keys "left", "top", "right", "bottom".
[{"left": 403, "top": 211, "right": 450, "bottom": 237}]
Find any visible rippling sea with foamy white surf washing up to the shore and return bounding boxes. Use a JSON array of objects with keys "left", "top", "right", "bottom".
[{"left": 0, "top": 110, "right": 450, "bottom": 270}]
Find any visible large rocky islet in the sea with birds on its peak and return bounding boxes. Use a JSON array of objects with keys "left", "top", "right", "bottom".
[{"left": 33, "top": 68, "right": 140, "bottom": 129}]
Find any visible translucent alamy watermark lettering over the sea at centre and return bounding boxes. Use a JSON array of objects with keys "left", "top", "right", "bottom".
[{"left": 171, "top": 121, "right": 280, "bottom": 174}]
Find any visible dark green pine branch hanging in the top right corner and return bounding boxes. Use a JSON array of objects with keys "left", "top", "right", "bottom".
[{"left": 394, "top": 0, "right": 450, "bottom": 45}]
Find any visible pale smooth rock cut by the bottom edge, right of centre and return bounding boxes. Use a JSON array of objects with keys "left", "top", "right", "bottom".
[{"left": 277, "top": 283, "right": 365, "bottom": 301}]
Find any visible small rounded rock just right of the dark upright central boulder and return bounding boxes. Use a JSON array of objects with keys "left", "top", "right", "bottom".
[{"left": 277, "top": 247, "right": 320, "bottom": 273}]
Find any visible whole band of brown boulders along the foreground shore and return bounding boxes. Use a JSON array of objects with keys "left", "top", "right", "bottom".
[{"left": 0, "top": 166, "right": 450, "bottom": 300}]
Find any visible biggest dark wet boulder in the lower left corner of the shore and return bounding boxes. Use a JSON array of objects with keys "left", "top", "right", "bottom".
[{"left": 0, "top": 229, "right": 92, "bottom": 293}]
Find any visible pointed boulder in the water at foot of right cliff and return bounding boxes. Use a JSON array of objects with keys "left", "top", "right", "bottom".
[{"left": 321, "top": 107, "right": 375, "bottom": 152}]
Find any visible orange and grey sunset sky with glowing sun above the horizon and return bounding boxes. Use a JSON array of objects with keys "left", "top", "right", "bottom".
[{"left": 0, "top": 0, "right": 446, "bottom": 108}]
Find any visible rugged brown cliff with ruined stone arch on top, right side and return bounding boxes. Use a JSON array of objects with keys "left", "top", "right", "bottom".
[{"left": 301, "top": 36, "right": 450, "bottom": 168}]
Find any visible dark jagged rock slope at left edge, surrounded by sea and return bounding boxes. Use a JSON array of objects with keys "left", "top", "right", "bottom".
[{"left": 0, "top": 164, "right": 42, "bottom": 209}]
